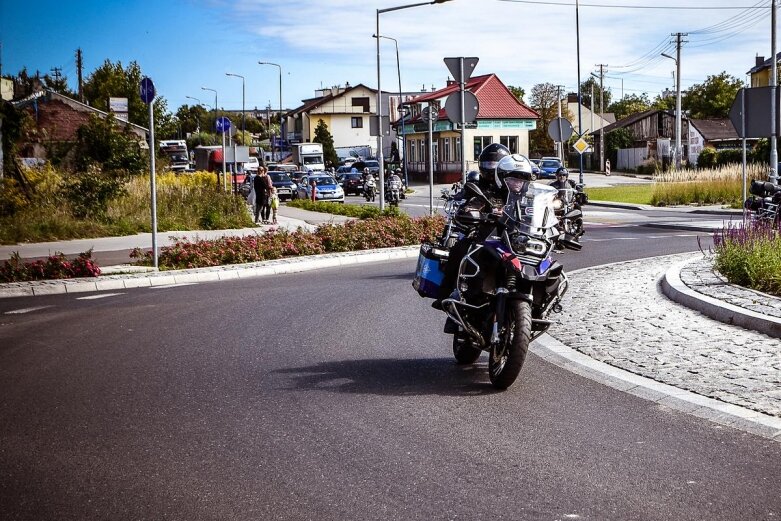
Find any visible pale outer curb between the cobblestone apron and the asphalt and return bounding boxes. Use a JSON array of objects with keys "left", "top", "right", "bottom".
[{"left": 530, "top": 334, "right": 781, "bottom": 442}]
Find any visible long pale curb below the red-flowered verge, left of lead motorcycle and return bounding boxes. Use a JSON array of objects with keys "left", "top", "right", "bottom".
[{"left": 0, "top": 244, "right": 420, "bottom": 298}]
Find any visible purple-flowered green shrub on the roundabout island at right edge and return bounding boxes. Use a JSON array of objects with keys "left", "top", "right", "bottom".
[{"left": 713, "top": 222, "right": 781, "bottom": 296}]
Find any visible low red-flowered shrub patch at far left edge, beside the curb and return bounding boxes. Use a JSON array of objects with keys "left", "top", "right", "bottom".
[{"left": 0, "top": 250, "right": 100, "bottom": 282}]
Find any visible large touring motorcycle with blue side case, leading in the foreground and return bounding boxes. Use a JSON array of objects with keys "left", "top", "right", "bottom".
[{"left": 412, "top": 177, "right": 580, "bottom": 389}]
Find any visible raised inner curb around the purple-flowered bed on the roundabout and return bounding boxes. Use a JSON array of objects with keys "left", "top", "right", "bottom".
[{"left": 661, "top": 259, "right": 781, "bottom": 338}]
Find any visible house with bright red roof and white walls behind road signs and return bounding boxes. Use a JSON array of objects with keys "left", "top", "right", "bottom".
[{"left": 397, "top": 74, "right": 540, "bottom": 183}]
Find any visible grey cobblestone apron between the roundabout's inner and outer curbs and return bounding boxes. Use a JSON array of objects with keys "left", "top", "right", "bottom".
[{"left": 550, "top": 253, "right": 781, "bottom": 422}]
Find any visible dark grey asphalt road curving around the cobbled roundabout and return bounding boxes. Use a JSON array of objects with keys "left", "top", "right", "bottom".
[{"left": 0, "top": 224, "right": 781, "bottom": 520}]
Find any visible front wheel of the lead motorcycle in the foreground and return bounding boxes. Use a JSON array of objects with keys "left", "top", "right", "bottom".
[{"left": 488, "top": 300, "right": 532, "bottom": 389}]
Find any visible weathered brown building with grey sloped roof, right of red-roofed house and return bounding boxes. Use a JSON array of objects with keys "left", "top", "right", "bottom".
[{"left": 594, "top": 109, "right": 689, "bottom": 170}]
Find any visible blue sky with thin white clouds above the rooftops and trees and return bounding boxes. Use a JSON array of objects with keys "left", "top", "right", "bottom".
[{"left": 0, "top": 0, "right": 781, "bottom": 116}]
